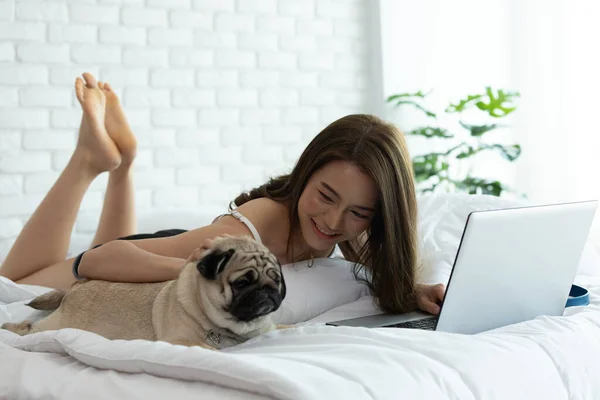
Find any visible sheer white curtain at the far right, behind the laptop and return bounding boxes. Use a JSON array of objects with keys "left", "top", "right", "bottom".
[{"left": 511, "top": 0, "right": 600, "bottom": 201}]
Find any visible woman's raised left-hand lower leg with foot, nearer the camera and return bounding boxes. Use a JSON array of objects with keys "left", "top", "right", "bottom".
[{"left": 0, "top": 73, "right": 121, "bottom": 286}]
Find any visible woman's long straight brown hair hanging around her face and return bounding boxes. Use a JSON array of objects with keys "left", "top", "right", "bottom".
[{"left": 230, "top": 114, "right": 417, "bottom": 312}]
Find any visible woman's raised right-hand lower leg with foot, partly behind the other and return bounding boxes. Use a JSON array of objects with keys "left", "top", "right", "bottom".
[{"left": 91, "top": 82, "right": 137, "bottom": 247}]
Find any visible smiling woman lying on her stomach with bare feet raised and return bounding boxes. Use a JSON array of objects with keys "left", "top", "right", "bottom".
[{"left": 0, "top": 73, "right": 444, "bottom": 314}]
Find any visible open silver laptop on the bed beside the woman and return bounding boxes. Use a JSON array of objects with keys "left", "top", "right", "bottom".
[{"left": 327, "top": 200, "right": 598, "bottom": 334}]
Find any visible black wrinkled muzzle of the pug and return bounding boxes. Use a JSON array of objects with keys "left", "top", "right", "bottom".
[{"left": 230, "top": 286, "right": 282, "bottom": 322}]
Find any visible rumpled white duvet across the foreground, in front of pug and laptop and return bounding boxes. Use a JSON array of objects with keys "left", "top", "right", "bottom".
[{"left": 0, "top": 276, "right": 600, "bottom": 399}]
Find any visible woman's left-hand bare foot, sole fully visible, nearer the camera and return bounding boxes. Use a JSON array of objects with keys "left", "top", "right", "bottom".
[{"left": 74, "top": 72, "right": 121, "bottom": 173}]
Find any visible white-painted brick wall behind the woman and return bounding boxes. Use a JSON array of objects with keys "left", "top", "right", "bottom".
[{"left": 0, "top": 0, "right": 373, "bottom": 261}]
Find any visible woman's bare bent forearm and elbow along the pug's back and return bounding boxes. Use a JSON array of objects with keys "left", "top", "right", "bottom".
[{"left": 78, "top": 240, "right": 185, "bottom": 283}]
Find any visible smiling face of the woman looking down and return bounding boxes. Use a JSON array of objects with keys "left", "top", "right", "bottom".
[{"left": 298, "top": 161, "right": 377, "bottom": 251}]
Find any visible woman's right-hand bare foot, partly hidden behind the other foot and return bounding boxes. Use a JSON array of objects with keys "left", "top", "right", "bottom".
[{"left": 98, "top": 82, "right": 137, "bottom": 166}]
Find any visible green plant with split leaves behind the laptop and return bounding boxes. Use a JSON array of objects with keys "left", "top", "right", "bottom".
[{"left": 386, "top": 87, "right": 521, "bottom": 196}]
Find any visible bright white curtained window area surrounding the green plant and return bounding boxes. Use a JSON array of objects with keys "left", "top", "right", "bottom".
[{"left": 376, "top": 0, "right": 600, "bottom": 244}]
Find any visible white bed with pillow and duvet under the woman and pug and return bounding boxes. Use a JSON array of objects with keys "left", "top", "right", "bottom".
[{"left": 0, "top": 194, "right": 600, "bottom": 400}]
